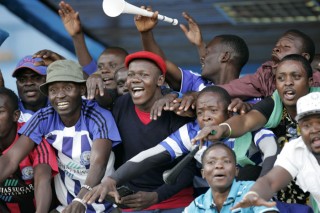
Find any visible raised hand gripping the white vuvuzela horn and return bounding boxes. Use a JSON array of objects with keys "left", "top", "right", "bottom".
[{"left": 134, "top": 6, "right": 158, "bottom": 33}]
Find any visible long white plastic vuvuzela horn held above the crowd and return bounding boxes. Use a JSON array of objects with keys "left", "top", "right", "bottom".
[{"left": 102, "top": 0, "right": 178, "bottom": 25}]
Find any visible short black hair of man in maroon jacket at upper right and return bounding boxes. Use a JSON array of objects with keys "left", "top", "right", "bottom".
[{"left": 283, "top": 29, "right": 316, "bottom": 63}]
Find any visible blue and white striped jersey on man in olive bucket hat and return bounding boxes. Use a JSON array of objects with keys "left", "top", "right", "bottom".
[{"left": 19, "top": 100, "right": 121, "bottom": 212}]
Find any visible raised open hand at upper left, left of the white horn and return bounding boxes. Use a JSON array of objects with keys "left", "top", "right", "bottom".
[{"left": 58, "top": 1, "right": 82, "bottom": 37}]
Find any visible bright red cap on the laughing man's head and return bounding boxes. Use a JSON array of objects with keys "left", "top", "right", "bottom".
[{"left": 125, "top": 51, "right": 167, "bottom": 75}]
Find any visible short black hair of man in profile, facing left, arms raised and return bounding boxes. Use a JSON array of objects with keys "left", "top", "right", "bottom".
[{"left": 216, "top": 34, "right": 249, "bottom": 68}]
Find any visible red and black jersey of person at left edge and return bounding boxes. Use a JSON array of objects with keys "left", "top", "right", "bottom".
[{"left": 0, "top": 123, "right": 58, "bottom": 213}]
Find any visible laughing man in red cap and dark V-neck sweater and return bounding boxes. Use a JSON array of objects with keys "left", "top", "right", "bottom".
[{"left": 84, "top": 51, "right": 195, "bottom": 212}]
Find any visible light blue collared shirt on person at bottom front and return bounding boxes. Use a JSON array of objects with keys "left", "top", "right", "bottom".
[{"left": 184, "top": 180, "right": 278, "bottom": 213}]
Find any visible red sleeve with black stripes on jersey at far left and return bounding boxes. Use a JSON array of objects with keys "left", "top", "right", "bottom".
[{"left": 31, "top": 138, "right": 59, "bottom": 176}]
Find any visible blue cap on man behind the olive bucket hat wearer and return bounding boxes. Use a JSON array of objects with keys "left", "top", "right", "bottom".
[{"left": 12, "top": 55, "right": 47, "bottom": 77}]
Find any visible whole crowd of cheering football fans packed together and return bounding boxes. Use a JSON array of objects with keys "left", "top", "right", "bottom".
[{"left": 0, "top": 1, "right": 320, "bottom": 213}]
